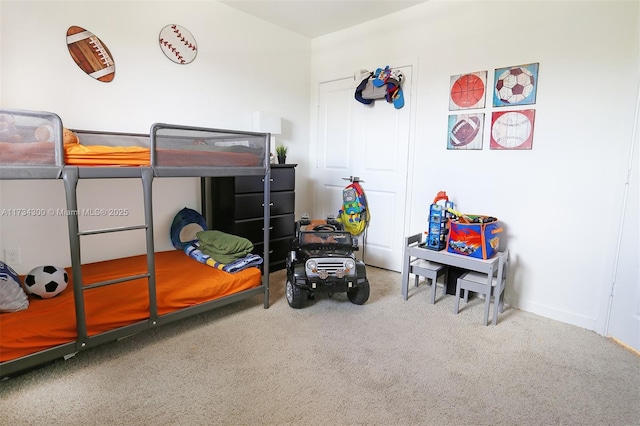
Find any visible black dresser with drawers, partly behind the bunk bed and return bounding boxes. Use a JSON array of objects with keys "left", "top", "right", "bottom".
[{"left": 202, "top": 164, "right": 296, "bottom": 272}]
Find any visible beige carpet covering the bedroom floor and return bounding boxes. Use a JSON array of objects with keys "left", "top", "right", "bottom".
[{"left": 0, "top": 267, "right": 640, "bottom": 425}]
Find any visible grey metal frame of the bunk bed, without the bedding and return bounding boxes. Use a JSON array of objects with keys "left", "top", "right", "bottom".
[{"left": 0, "top": 110, "right": 271, "bottom": 378}]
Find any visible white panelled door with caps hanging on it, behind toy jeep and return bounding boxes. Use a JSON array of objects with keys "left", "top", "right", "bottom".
[{"left": 314, "top": 66, "right": 412, "bottom": 271}]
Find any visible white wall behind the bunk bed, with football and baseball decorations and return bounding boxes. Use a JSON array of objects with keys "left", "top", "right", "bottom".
[{"left": 0, "top": 0, "right": 311, "bottom": 273}]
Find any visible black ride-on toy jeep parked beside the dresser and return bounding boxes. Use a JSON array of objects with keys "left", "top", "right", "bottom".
[{"left": 285, "top": 215, "right": 369, "bottom": 309}]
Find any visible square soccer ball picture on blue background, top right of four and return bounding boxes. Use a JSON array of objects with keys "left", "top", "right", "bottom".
[{"left": 493, "top": 62, "right": 538, "bottom": 107}]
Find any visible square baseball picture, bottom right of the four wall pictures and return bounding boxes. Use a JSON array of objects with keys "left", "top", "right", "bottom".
[{"left": 489, "top": 109, "right": 536, "bottom": 149}]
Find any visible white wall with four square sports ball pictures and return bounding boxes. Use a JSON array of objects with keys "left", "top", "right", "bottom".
[{"left": 311, "top": 1, "right": 640, "bottom": 332}]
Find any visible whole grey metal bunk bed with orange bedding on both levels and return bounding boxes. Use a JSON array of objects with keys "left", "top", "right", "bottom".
[{"left": 0, "top": 109, "right": 270, "bottom": 378}]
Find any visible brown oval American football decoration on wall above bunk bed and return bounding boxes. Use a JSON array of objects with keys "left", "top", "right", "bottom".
[{"left": 67, "top": 26, "right": 116, "bottom": 83}]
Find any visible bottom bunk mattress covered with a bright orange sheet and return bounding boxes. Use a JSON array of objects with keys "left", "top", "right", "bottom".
[{"left": 0, "top": 250, "right": 262, "bottom": 362}]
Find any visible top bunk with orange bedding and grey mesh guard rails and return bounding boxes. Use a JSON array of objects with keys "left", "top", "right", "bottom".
[{"left": 0, "top": 109, "right": 270, "bottom": 178}]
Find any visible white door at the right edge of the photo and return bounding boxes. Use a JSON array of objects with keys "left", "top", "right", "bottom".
[{"left": 607, "top": 100, "right": 640, "bottom": 352}]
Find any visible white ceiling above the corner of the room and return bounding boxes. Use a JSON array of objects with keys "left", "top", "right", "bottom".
[{"left": 221, "top": 0, "right": 428, "bottom": 38}]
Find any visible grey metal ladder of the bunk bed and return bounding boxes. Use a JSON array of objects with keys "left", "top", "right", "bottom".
[{"left": 62, "top": 166, "right": 158, "bottom": 350}]
